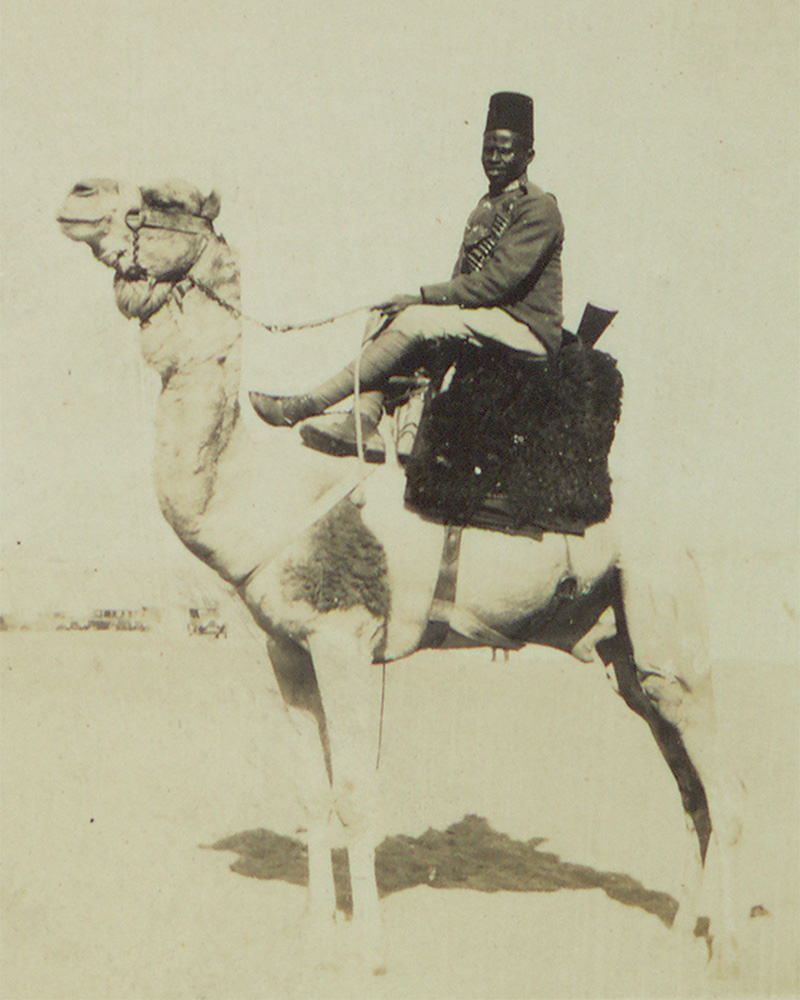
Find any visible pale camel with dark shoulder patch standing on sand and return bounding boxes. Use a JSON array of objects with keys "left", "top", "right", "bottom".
[{"left": 58, "top": 179, "right": 740, "bottom": 972}]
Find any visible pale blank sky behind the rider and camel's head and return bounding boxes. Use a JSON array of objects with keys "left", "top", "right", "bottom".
[{"left": 0, "top": 0, "right": 800, "bottom": 657}]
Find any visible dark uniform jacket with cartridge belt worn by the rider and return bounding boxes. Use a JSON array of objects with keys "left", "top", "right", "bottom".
[{"left": 421, "top": 177, "right": 564, "bottom": 351}]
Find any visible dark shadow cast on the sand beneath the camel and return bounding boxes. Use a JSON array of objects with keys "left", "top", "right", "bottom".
[{"left": 209, "top": 816, "right": 678, "bottom": 927}]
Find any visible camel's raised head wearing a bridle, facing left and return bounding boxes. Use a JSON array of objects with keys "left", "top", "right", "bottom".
[{"left": 57, "top": 178, "right": 220, "bottom": 319}]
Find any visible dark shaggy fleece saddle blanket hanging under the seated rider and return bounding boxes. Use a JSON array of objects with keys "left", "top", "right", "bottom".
[{"left": 405, "top": 337, "right": 622, "bottom": 536}]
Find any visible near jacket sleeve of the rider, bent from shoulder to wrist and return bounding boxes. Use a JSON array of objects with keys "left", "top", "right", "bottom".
[{"left": 421, "top": 195, "right": 564, "bottom": 309}]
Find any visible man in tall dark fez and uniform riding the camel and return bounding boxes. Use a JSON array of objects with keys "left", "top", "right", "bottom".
[{"left": 250, "top": 92, "right": 564, "bottom": 461}]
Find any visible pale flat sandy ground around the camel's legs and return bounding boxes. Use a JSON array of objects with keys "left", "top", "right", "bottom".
[{"left": 2, "top": 633, "right": 800, "bottom": 1000}]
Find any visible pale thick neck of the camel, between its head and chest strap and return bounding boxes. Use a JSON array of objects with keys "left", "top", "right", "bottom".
[{"left": 142, "top": 237, "right": 356, "bottom": 584}]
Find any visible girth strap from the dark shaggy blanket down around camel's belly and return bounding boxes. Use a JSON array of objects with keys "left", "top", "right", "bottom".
[{"left": 420, "top": 524, "right": 525, "bottom": 649}]
